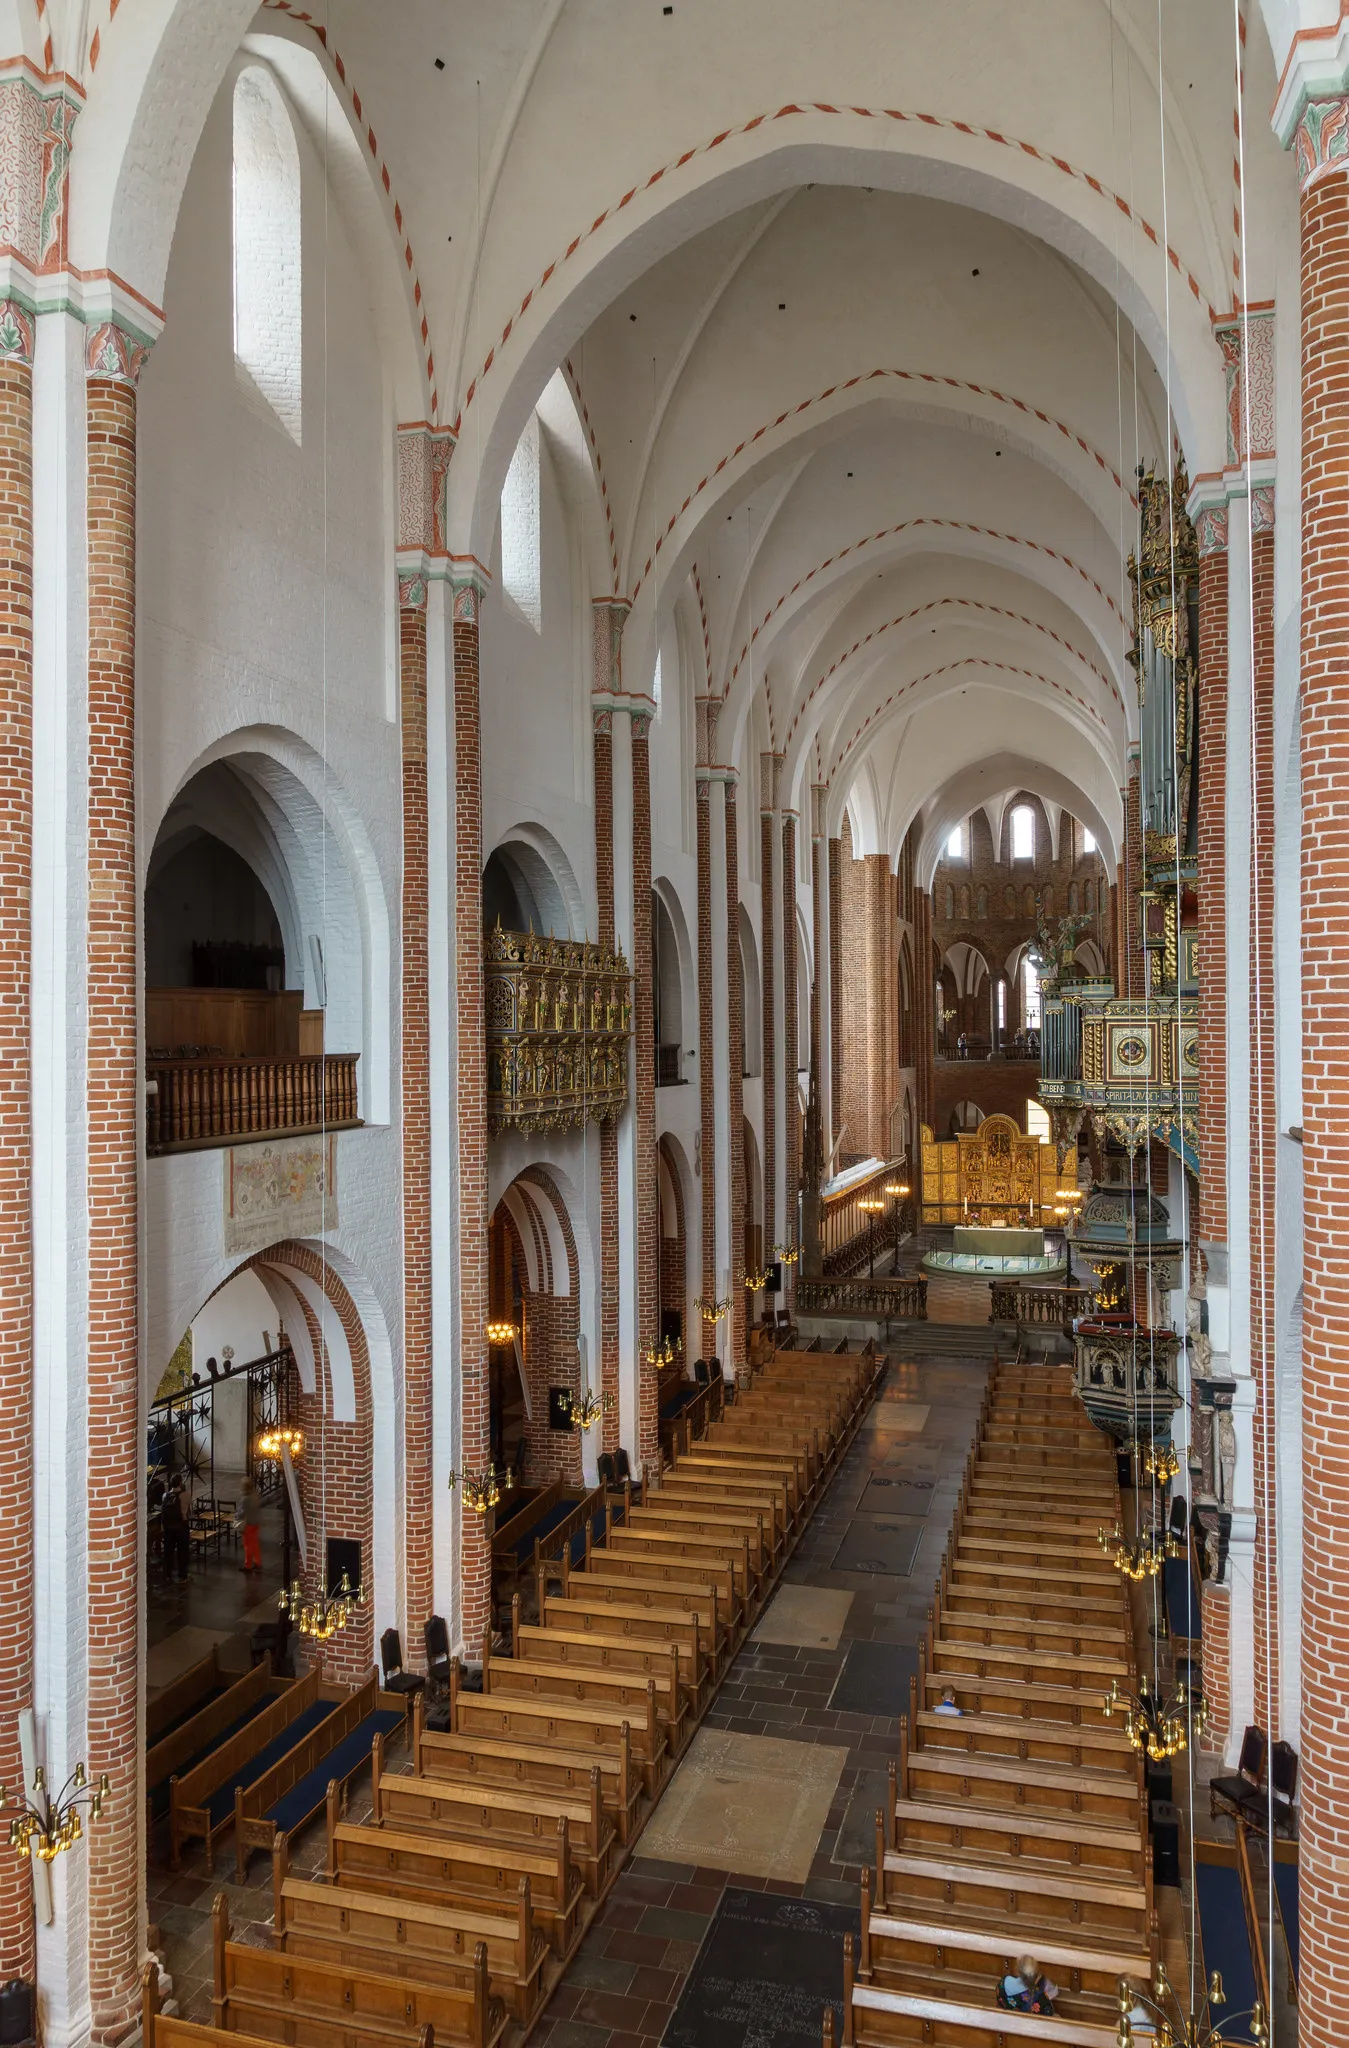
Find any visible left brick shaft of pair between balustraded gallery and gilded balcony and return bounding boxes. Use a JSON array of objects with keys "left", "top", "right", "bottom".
[{"left": 399, "top": 573, "right": 436, "bottom": 1665}]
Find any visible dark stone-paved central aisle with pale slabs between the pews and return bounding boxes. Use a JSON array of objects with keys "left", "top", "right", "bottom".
[{"left": 534, "top": 1354, "right": 991, "bottom": 2048}]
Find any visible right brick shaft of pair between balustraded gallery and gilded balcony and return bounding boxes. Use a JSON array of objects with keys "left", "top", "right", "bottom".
[{"left": 452, "top": 575, "right": 491, "bottom": 1655}]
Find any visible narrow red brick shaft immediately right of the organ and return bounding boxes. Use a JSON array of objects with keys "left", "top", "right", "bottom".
[{"left": 1200, "top": 553, "right": 1228, "bottom": 1245}]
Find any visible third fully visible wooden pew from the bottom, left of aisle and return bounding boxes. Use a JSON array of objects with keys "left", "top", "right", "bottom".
[{"left": 371, "top": 1741, "right": 618, "bottom": 1898}]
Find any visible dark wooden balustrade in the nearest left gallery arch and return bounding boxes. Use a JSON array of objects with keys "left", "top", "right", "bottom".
[{"left": 145, "top": 1053, "right": 360, "bottom": 1155}]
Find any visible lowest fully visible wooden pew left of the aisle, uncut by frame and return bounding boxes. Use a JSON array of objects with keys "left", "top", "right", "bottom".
[{"left": 272, "top": 1835, "right": 551, "bottom": 2025}]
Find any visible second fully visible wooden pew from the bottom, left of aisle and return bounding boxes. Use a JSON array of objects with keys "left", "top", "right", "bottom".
[{"left": 328, "top": 1788, "right": 585, "bottom": 1958}]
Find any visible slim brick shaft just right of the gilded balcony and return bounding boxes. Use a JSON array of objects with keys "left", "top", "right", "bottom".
[{"left": 630, "top": 711, "right": 659, "bottom": 1466}]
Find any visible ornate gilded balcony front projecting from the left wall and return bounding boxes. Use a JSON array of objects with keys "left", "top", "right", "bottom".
[{"left": 483, "top": 922, "right": 633, "bottom": 1137}]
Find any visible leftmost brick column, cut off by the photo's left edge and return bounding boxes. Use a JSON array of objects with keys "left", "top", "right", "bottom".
[{"left": 0, "top": 301, "right": 37, "bottom": 1980}]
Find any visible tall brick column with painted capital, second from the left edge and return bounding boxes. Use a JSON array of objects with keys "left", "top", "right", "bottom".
[{"left": 86, "top": 307, "right": 147, "bottom": 2044}]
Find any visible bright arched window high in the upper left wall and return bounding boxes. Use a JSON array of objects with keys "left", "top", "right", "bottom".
[{"left": 233, "top": 63, "right": 301, "bottom": 446}]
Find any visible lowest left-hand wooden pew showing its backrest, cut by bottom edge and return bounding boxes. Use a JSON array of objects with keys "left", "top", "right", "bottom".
[{"left": 211, "top": 1896, "right": 508, "bottom": 2048}]
